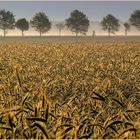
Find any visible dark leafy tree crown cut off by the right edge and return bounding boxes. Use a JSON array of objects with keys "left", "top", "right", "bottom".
[{"left": 129, "top": 10, "right": 140, "bottom": 30}]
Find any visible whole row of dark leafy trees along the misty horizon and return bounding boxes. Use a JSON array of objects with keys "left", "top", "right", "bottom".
[{"left": 0, "top": 9, "right": 140, "bottom": 37}]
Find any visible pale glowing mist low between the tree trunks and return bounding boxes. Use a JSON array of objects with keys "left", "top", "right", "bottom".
[{"left": 0, "top": 21, "right": 140, "bottom": 36}]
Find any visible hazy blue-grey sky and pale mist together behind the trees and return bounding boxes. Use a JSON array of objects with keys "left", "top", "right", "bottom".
[{"left": 0, "top": 1, "right": 140, "bottom": 36}]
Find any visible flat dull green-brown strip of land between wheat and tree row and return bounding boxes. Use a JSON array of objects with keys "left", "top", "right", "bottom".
[{"left": 0, "top": 36, "right": 140, "bottom": 44}]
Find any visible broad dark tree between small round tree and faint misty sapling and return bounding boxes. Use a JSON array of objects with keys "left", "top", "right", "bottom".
[{"left": 30, "top": 12, "right": 51, "bottom": 37}]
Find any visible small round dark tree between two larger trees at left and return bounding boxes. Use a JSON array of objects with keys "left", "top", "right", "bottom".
[{"left": 16, "top": 18, "right": 29, "bottom": 37}]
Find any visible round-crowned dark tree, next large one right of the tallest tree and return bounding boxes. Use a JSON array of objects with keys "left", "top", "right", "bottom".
[{"left": 101, "top": 14, "right": 120, "bottom": 36}]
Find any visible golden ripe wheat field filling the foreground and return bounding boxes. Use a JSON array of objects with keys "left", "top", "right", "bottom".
[{"left": 0, "top": 42, "right": 140, "bottom": 139}]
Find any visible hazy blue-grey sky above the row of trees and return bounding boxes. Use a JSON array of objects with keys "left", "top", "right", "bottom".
[{"left": 0, "top": 1, "right": 140, "bottom": 35}]
